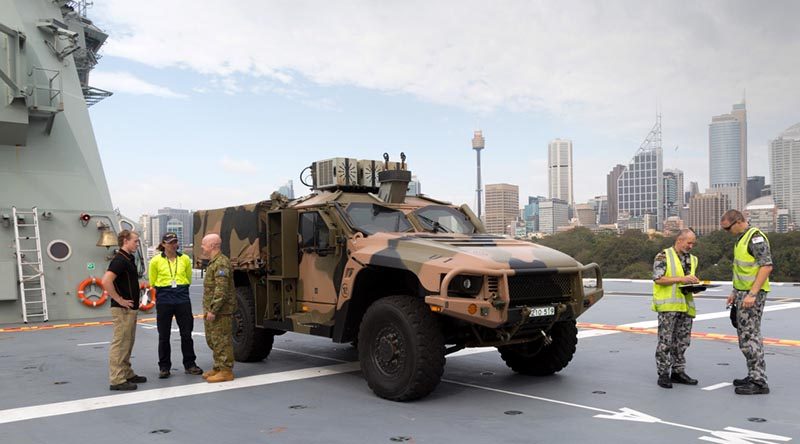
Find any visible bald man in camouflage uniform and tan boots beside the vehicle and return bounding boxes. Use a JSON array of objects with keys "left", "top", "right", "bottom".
[{"left": 201, "top": 234, "right": 236, "bottom": 382}]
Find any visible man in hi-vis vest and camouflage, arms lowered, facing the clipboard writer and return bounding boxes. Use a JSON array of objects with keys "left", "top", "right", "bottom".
[{"left": 720, "top": 210, "right": 772, "bottom": 395}]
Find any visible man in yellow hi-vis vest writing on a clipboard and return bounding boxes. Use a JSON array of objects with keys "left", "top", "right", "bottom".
[{"left": 652, "top": 229, "right": 700, "bottom": 388}]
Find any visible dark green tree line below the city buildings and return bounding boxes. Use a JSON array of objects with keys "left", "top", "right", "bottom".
[{"left": 534, "top": 227, "right": 800, "bottom": 282}]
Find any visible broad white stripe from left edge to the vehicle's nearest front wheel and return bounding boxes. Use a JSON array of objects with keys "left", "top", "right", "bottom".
[{"left": 0, "top": 362, "right": 359, "bottom": 424}]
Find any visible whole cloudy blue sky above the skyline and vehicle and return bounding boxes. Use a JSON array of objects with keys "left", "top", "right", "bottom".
[{"left": 83, "top": 0, "right": 800, "bottom": 217}]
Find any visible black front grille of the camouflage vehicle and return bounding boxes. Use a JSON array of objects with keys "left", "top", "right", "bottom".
[{"left": 508, "top": 273, "right": 575, "bottom": 307}]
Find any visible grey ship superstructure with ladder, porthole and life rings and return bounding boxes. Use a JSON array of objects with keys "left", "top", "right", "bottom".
[{"left": 0, "top": 0, "right": 141, "bottom": 323}]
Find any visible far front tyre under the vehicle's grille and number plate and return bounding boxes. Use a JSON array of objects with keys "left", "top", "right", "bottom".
[{"left": 497, "top": 321, "right": 578, "bottom": 376}]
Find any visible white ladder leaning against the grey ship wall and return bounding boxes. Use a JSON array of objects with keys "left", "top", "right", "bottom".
[{"left": 11, "top": 207, "right": 48, "bottom": 324}]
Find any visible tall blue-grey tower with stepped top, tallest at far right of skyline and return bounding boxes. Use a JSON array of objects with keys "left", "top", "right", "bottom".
[{"left": 708, "top": 102, "right": 747, "bottom": 210}]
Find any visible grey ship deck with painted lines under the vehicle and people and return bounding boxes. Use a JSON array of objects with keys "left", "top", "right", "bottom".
[{"left": 0, "top": 282, "right": 800, "bottom": 444}]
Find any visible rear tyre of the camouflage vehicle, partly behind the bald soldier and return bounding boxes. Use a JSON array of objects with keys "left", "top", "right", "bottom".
[{"left": 231, "top": 286, "right": 275, "bottom": 362}]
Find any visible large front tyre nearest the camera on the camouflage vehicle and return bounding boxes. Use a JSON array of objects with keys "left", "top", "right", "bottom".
[{"left": 358, "top": 296, "right": 445, "bottom": 401}]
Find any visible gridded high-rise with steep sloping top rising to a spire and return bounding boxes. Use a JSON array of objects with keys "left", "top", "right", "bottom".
[{"left": 617, "top": 115, "right": 664, "bottom": 227}]
